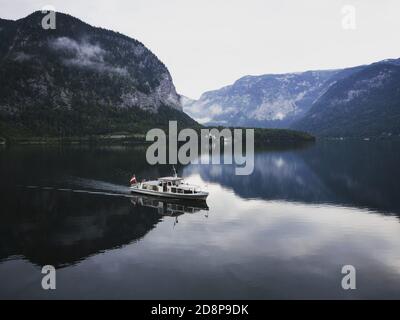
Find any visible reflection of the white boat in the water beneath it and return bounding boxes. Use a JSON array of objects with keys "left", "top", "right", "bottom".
[{"left": 131, "top": 196, "right": 209, "bottom": 221}]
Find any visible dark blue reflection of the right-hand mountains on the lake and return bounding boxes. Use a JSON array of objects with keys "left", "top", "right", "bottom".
[{"left": 184, "top": 141, "right": 400, "bottom": 215}]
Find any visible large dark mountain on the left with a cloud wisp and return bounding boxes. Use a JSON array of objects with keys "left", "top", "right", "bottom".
[{"left": 0, "top": 12, "right": 198, "bottom": 136}]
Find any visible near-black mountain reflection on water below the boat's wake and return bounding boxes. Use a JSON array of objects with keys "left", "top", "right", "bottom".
[{"left": 0, "top": 187, "right": 208, "bottom": 267}]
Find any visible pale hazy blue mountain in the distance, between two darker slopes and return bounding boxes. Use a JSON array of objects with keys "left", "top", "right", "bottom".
[{"left": 182, "top": 70, "right": 340, "bottom": 128}]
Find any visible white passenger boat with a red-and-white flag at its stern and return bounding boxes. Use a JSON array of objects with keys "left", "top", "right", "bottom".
[{"left": 130, "top": 168, "right": 208, "bottom": 200}]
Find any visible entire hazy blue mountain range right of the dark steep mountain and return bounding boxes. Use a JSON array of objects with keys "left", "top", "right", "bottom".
[{"left": 187, "top": 59, "right": 400, "bottom": 137}]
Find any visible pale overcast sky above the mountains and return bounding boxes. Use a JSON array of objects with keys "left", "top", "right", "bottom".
[{"left": 0, "top": 0, "right": 400, "bottom": 98}]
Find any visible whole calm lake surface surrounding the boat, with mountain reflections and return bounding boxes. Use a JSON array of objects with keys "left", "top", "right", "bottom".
[{"left": 0, "top": 140, "right": 400, "bottom": 299}]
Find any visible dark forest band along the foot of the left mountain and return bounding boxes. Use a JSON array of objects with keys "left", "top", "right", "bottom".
[{"left": 0, "top": 102, "right": 198, "bottom": 138}]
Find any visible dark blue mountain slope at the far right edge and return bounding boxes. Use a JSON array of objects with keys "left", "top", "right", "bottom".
[{"left": 292, "top": 60, "right": 400, "bottom": 137}]
